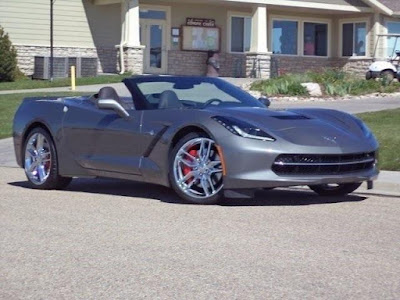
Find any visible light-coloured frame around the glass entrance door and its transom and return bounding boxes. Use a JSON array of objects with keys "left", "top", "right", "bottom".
[{"left": 139, "top": 4, "right": 171, "bottom": 74}]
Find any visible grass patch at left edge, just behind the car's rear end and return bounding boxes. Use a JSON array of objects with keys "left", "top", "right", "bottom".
[{"left": 0, "top": 92, "right": 86, "bottom": 139}]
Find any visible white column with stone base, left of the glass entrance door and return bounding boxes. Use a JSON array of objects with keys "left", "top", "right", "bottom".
[{"left": 120, "top": 0, "right": 145, "bottom": 74}]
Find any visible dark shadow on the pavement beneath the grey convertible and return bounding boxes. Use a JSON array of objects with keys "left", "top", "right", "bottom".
[{"left": 8, "top": 178, "right": 367, "bottom": 206}]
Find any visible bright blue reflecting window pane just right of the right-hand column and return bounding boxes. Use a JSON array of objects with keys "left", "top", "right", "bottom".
[{"left": 272, "top": 20, "right": 299, "bottom": 55}]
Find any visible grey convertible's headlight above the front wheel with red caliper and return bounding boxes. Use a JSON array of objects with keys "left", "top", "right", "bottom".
[{"left": 212, "top": 116, "right": 275, "bottom": 142}]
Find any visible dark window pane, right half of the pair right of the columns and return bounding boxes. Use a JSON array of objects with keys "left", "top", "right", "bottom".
[{"left": 304, "top": 22, "right": 328, "bottom": 56}]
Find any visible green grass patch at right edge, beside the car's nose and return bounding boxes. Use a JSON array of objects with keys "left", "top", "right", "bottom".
[{"left": 358, "top": 108, "right": 400, "bottom": 171}]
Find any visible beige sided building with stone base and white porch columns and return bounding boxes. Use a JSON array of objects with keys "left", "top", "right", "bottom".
[{"left": 0, "top": 0, "right": 400, "bottom": 78}]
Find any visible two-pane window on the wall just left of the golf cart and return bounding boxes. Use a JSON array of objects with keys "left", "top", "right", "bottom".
[{"left": 342, "top": 22, "right": 367, "bottom": 56}]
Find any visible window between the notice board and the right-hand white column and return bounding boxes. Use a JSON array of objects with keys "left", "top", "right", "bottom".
[{"left": 231, "top": 17, "right": 251, "bottom": 52}]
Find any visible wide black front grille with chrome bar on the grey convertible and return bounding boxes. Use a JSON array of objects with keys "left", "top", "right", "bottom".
[{"left": 272, "top": 152, "right": 375, "bottom": 175}]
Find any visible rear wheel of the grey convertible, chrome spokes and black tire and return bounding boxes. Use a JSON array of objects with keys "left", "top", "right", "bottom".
[{"left": 24, "top": 128, "right": 72, "bottom": 190}]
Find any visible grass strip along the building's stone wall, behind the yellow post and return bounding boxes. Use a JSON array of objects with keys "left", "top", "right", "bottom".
[{"left": 0, "top": 74, "right": 131, "bottom": 91}]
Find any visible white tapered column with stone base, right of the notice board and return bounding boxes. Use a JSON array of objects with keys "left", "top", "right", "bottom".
[{"left": 246, "top": 5, "right": 271, "bottom": 79}]
